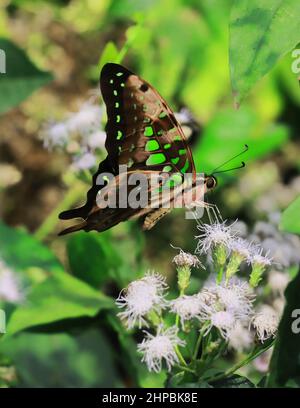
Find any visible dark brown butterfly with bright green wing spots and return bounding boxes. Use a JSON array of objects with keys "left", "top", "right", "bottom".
[{"left": 59, "top": 63, "right": 217, "bottom": 235}]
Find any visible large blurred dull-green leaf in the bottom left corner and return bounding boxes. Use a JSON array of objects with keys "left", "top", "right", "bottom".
[{"left": 0, "top": 328, "right": 122, "bottom": 388}]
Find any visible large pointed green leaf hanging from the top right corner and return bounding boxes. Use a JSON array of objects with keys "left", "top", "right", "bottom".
[{"left": 229, "top": 0, "right": 300, "bottom": 104}]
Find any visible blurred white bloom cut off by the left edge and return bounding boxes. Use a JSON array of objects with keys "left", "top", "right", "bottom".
[{"left": 0, "top": 260, "right": 24, "bottom": 303}]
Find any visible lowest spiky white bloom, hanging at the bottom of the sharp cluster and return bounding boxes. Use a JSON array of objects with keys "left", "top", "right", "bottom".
[{"left": 138, "top": 326, "right": 185, "bottom": 373}]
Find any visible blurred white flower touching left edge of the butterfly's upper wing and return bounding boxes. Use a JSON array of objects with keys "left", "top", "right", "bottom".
[{"left": 67, "top": 102, "right": 103, "bottom": 135}]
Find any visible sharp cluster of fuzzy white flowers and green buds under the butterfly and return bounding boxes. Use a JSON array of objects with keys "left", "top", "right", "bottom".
[{"left": 116, "top": 222, "right": 279, "bottom": 372}]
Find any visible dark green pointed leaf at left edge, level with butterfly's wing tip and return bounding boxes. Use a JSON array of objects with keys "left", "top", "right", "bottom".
[{"left": 0, "top": 38, "right": 52, "bottom": 113}]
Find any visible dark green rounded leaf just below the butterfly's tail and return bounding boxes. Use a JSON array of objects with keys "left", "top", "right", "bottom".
[{"left": 67, "top": 232, "right": 121, "bottom": 287}]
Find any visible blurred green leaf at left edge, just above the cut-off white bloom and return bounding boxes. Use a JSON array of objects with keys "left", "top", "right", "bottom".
[{"left": 0, "top": 222, "right": 64, "bottom": 273}]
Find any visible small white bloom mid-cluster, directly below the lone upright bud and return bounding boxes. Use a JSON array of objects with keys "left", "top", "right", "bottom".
[{"left": 170, "top": 295, "right": 202, "bottom": 325}]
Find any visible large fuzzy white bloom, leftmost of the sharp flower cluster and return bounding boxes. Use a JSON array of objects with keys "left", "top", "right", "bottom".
[{"left": 116, "top": 273, "right": 167, "bottom": 329}]
